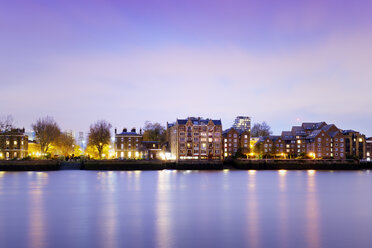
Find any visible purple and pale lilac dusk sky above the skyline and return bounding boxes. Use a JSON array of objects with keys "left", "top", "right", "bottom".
[{"left": 0, "top": 0, "right": 372, "bottom": 136}]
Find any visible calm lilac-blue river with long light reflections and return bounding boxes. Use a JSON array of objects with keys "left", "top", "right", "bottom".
[{"left": 0, "top": 171, "right": 372, "bottom": 248}]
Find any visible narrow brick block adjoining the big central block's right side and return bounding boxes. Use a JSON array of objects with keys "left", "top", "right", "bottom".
[{"left": 222, "top": 127, "right": 251, "bottom": 158}]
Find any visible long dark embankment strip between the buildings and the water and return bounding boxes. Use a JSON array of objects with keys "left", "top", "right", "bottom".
[{"left": 0, "top": 159, "right": 372, "bottom": 171}]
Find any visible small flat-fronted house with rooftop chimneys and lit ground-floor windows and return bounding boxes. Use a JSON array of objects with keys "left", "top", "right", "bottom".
[{"left": 114, "top": 128, "right": 143, "bottom": 159}]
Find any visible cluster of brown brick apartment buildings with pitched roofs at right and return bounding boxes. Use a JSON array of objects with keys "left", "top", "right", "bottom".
[{"left": 256, "top": 122, "right": 366, "bottom": 159}]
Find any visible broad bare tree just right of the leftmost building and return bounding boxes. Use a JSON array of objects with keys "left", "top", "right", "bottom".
[{"left": 32, "top": 116, "right": 61, "bottom": 154}]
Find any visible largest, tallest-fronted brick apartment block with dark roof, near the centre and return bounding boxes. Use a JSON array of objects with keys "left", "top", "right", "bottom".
[{"left": 167, "top": 117, "right": 223, "bottom": 160}]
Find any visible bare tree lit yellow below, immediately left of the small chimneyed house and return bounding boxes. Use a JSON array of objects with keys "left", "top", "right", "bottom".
[{"left": 88, "top": 120, "right": 111, "bottom": 158}]
